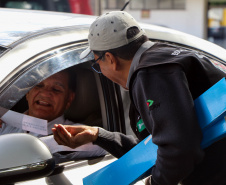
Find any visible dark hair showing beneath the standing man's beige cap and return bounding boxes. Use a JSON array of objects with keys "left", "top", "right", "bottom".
[{"left": 93, "top": 27, "right": 148, "bottom": 60}]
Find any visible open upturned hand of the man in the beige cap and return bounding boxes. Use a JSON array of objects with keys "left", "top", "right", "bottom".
[{"left": 52, "top": 124, "right": 98, "bottom": 148}]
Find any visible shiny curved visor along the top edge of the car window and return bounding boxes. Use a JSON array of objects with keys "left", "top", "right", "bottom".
[{"left": 0, "top": 43, "right": 89, "bottom": 109}]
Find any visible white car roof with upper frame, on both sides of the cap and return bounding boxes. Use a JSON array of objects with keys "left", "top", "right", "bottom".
[{"left": 0, "top": 8, "right": 226, "bottom": 81}]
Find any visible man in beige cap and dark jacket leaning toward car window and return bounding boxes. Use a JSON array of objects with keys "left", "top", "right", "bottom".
[{"left": 52, "top": 11, "right": 226, "bottom": 185}]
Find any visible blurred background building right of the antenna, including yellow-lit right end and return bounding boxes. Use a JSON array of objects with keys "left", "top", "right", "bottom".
[{"left": 101, "top": 0, "right": 226, "bottom": 48}]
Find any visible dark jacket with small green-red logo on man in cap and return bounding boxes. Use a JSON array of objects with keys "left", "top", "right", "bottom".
[{"left": 96, "top": 43, "right": 226, "bottom": 185}]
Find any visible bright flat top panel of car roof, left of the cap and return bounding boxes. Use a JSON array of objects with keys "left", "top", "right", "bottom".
[{"left": 0, "top": 8, "right": 95, "bottom": 47}]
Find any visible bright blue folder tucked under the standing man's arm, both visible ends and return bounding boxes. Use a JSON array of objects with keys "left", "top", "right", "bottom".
[{"left": 83, "top": 78, "right": 226, "bottom": 185}]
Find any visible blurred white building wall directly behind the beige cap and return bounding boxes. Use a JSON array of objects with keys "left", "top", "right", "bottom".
[{"left": 103, "top": 0, "right": 208, "bottom": 38}]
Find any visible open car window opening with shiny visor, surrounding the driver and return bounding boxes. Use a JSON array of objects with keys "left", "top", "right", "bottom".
[{"left": 0, "top": 42, "right": 109, "bottom": 132}]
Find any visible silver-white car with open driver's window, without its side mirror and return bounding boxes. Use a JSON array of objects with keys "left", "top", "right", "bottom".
[{"left": 0, "top": 9, "right": 226, "bottom": 185}]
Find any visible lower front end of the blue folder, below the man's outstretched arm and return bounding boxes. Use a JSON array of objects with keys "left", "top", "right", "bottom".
[{"left": 83, "top": 136, "right": 158, "bottom": 185}]
